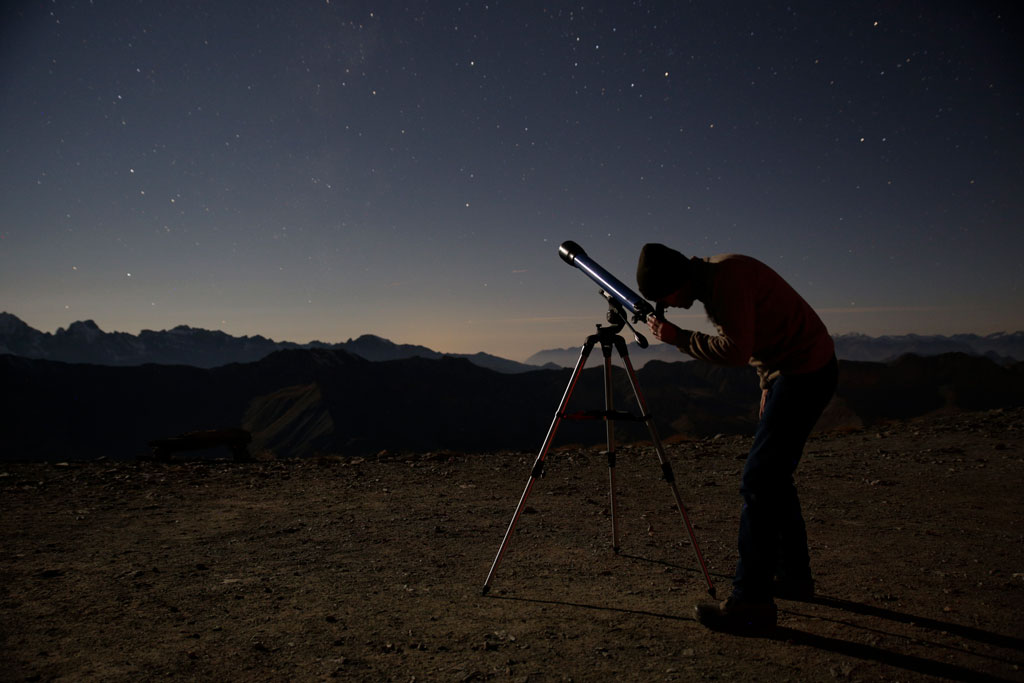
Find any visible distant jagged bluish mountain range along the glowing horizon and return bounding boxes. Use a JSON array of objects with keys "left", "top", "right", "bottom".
[{"left": 0, "top": 313, "right": 1024, "bottom": 373}]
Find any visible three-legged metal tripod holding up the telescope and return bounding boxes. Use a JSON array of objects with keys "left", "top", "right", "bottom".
[{"left": 483, "top": 303, "right": 715, "bottom": 597}]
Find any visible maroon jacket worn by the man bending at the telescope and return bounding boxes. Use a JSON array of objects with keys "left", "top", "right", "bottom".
[{"left": 679, "top": 254, "right": 836, "bottom": 388}]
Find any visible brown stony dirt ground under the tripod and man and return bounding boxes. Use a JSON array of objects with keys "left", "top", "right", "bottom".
[{"left": 0, "top": 410, "right": 1024, "bottom": 681}]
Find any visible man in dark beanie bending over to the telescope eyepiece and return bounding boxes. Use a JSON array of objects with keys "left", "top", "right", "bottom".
[{"left": 637, "top": 244, "right": 839, "bottom": 631}]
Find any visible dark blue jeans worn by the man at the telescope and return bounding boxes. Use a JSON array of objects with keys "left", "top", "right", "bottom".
[{"left": 732, "top": 358, "right": 839, "bottom": 601}]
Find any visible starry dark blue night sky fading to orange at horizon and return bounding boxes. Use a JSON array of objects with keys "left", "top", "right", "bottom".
[{"left": 0, "top": 0, "right": 1024, "bottom": 360}]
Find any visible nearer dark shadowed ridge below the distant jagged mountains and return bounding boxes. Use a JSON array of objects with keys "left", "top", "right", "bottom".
[{"left": 0, "top": 348, "right": 1024, "bottom": 461}]
